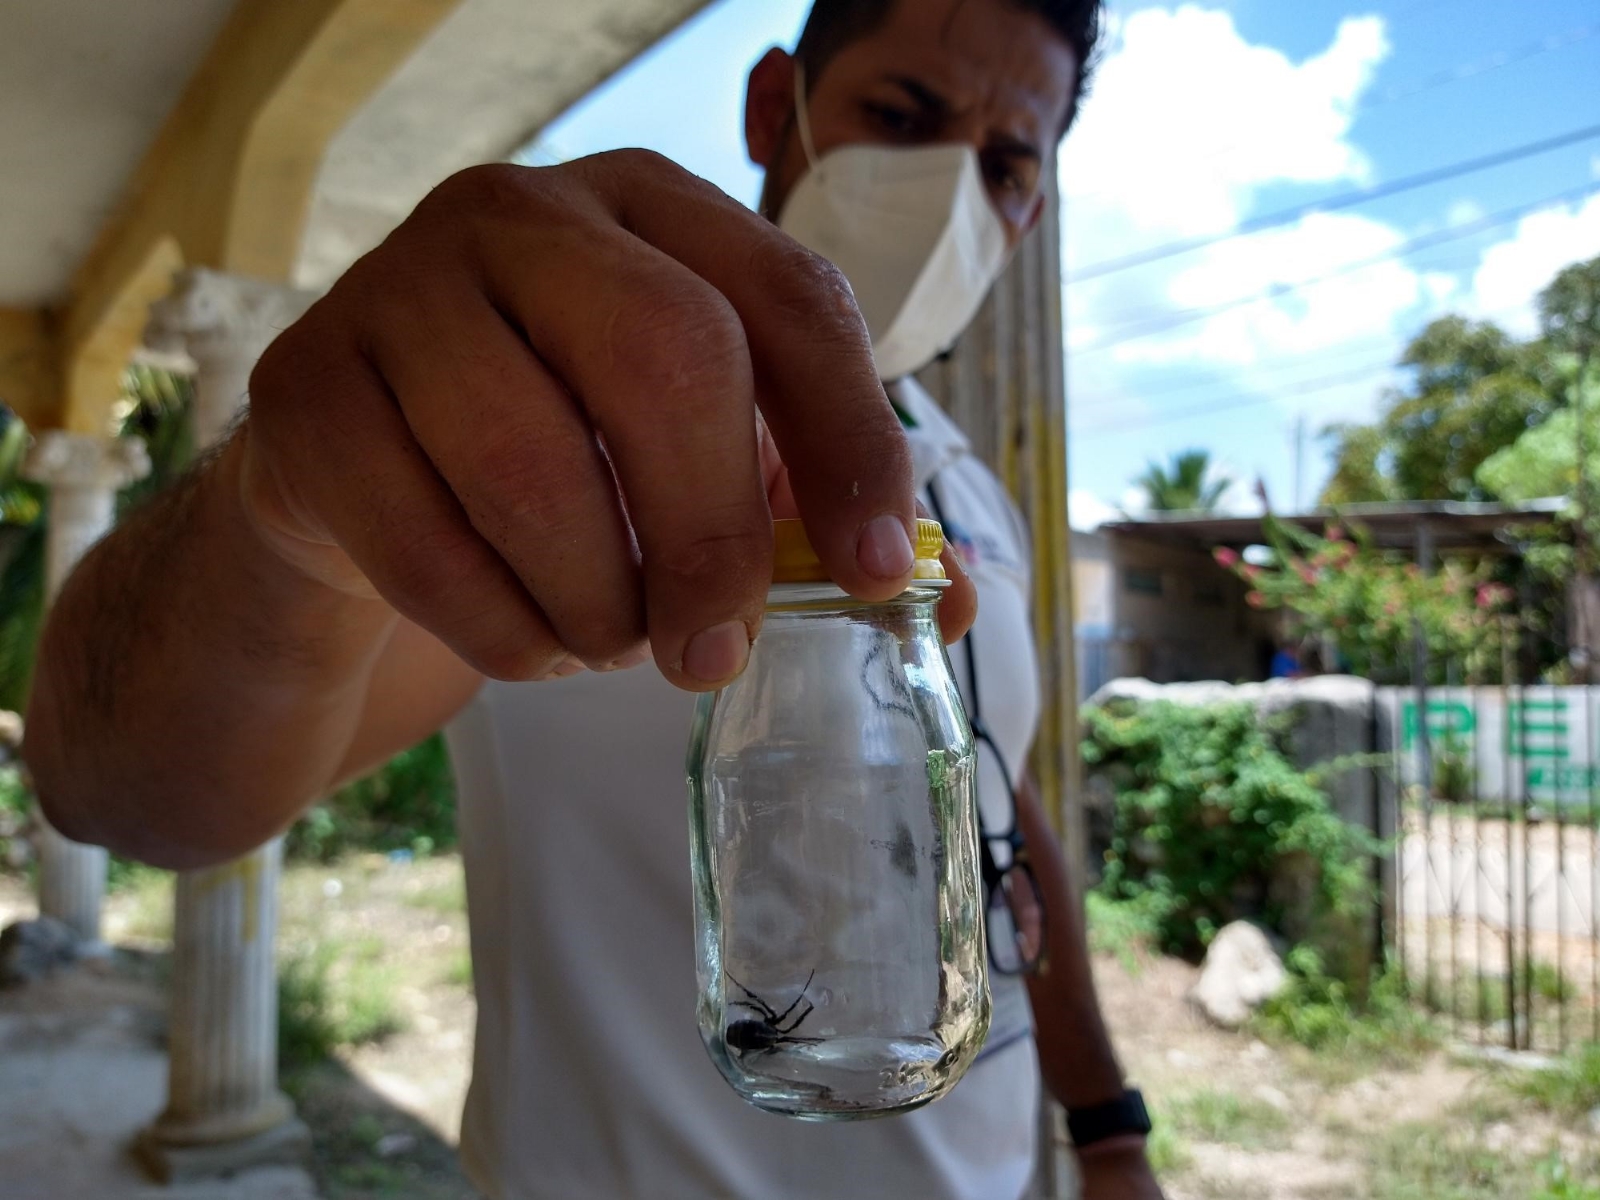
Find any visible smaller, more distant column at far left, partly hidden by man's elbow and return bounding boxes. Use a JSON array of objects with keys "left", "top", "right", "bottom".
[{"left": 22, "top": 430, "right": 150, "bottom": 952}]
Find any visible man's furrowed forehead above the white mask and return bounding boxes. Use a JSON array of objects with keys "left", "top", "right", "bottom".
[{"left": 840, "top": 0, "right": 1077, "bottom": 137}]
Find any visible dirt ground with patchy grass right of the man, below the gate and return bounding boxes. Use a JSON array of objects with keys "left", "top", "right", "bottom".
[{"left": 1096, "top": 958, "right": 1600, "bottom": 1200}]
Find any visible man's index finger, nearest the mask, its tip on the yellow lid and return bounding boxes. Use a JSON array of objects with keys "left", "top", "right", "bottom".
[{"left": 590, "top": 152, "right": 915, "bottom": 600}]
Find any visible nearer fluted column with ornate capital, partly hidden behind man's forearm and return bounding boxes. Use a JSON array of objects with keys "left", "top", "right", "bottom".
[{"left": 136, "top": 270, "right": 314, "bottom": 1182}]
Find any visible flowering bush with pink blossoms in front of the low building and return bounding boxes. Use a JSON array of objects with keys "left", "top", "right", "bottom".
[{"left": 1214, "top": 518, "right": 1515, "bottom": 682}]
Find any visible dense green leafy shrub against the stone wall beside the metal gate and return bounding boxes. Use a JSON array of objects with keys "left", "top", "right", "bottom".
[{"left": 1083, "top": 701, "right": 1374, "bottom": 955}]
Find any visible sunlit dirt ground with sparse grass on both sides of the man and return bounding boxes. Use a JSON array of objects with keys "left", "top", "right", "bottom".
[{"left": 0, "top": 858, "right": 1600, "bottom": 1200}]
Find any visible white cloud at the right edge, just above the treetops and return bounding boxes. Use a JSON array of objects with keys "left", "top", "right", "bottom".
[{"left": 1466, "top": 195, "right": 1600, "bottom": 338}]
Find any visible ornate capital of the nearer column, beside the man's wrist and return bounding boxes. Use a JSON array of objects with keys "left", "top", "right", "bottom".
[{"left": 144, "top": 267, "right": 317, "bottom": 363}]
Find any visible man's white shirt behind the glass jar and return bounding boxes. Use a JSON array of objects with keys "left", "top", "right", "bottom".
[{"left": 448, "top": 384, "right": 1038, "bottom": 1200}]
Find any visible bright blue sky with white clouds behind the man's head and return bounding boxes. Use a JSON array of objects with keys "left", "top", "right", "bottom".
[{"left": 528, "top": 0, "right": 1600, "bottom": 525}]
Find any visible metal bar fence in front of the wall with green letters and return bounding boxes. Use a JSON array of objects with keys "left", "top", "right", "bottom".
[{"left": 1376, "top": 685, "right": 1600, "bottom": 1051}]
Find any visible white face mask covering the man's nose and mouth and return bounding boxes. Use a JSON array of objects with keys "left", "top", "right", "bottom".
[{"left": 778, "top": 70, "right": 1006, "bottom": 379}]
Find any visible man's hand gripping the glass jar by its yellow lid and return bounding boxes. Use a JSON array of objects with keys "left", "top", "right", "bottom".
[{"left": 242, "top": 150, "right": 971, "bottom": 690}]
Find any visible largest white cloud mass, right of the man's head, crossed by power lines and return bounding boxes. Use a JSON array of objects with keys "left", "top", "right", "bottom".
[{"left": 1061, "top": 3, "right": 1420, "bottom": 451}]
